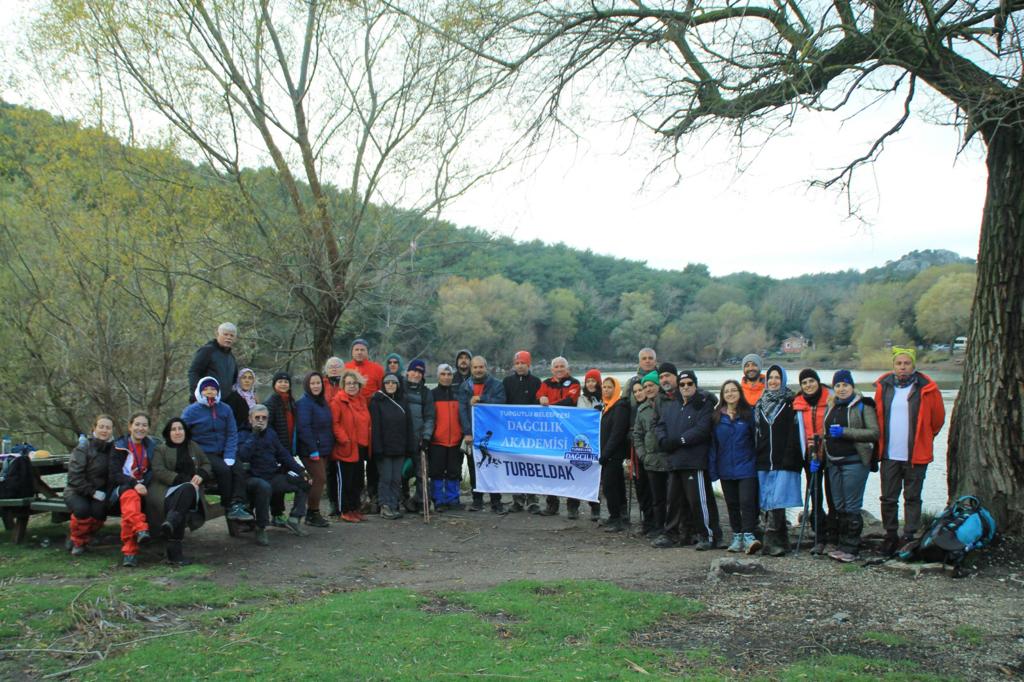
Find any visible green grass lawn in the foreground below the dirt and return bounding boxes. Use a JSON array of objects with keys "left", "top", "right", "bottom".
[{"left": 0, "top": 522, "right": 935, "bottom": 680}]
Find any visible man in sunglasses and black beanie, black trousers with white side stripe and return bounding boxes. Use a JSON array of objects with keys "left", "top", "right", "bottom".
[{"left": 654, "top": 370, "right": 722, "bottom": 551}]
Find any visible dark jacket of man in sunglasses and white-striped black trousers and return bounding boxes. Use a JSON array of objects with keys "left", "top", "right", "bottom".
[{"left": 654, "top": 390, "right": 718, "bottom": 471}]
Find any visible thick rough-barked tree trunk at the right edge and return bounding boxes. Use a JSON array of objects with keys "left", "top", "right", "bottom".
[{"left": 948, "top": 126, "right": 1024, "bottom": 534}]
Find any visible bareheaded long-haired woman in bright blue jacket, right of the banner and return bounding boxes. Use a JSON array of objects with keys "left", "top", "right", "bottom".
[{"left": 711, "top": 379, "right": 761, "bottom": 554}]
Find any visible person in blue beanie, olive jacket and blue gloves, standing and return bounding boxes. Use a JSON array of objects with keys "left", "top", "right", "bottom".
[{"left": 824, "top": 370, "right": 879, "bottom": 562}]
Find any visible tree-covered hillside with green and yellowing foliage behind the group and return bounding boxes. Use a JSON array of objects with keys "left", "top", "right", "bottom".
[{"left": 0, "top": 100, "right": 974, "bottom": 437}]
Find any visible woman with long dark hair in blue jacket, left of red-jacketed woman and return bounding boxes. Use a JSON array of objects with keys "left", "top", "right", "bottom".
[{"left": 295, "top": 372, "right": 334, "bottom": 528}]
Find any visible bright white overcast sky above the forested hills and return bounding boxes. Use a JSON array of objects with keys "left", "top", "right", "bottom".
[{"left": 0, "top": 0, "right": 986, "bottom": 278}]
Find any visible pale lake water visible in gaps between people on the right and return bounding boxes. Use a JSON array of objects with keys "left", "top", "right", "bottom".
[{"left": 610, "top": 368, "right": 961, "bottom": 518}]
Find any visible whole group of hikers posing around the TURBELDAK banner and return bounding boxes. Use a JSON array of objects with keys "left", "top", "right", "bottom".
[{"left": 65, "top": 323, "right": 945, "bottom": 566}]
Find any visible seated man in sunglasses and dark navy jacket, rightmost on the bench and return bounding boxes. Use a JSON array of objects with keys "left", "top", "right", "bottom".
[{"left": 239, "top": 404, "right": 309, "bottom": 547}]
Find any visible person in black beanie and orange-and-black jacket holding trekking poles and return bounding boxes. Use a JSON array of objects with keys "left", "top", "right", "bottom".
[{"left": 793, "top": 369, "right": 839, "bottom": 555}]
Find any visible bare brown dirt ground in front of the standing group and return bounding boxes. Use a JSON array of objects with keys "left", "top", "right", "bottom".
[{"left": 178, "top": 497, "right": 1024, "bottom": 679}]
